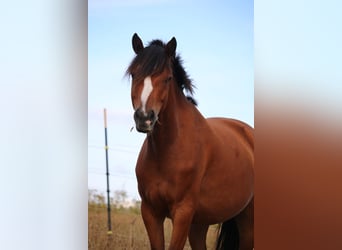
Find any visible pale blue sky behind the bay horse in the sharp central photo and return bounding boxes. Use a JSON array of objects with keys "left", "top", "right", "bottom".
[{"left": 88, "top": 0, "right": 254, "bottom": 198}]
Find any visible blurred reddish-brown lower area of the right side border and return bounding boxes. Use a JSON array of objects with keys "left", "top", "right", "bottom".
[{"left": 255, "top": 101, "right": 342, "bottom": 250}]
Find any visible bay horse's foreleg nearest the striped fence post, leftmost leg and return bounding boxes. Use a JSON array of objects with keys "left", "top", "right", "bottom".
[{"left": 141, "top": 201, "right": 165, "bottom": 250}]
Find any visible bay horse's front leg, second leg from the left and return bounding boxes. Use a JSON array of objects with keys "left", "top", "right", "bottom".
[{"left": 169, "top": 206, "right": 194, "bottom": 250}]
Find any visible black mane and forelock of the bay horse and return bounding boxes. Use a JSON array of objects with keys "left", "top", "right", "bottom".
[{"left": 126, "top": 40, "right": 195, "bottom": 96}]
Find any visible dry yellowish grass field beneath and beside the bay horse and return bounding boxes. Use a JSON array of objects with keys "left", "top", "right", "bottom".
[{"left": 88, "top": 206, "right": 216, "bottom": 250}]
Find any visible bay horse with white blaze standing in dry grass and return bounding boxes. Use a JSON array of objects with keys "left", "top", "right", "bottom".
[{"left": 126, "top": 33, "right": 254, "bottom": 250}]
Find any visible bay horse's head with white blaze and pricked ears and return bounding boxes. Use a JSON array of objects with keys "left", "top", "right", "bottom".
[{"left": 127, "top": 34, "right": 177, "bottom": 133}]
